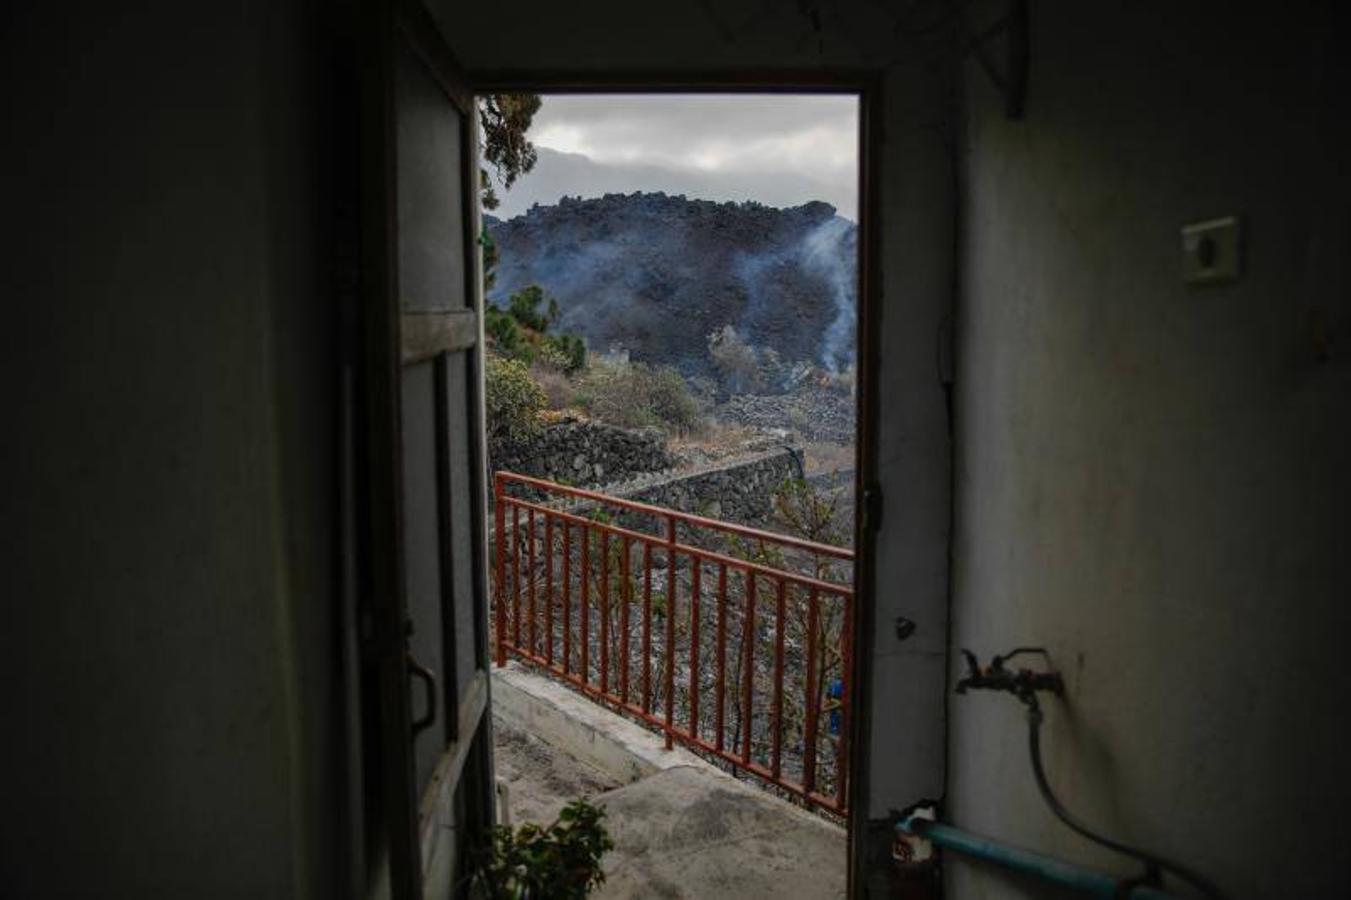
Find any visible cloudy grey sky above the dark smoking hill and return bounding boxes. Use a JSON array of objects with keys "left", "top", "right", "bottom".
[{"left": 493, "top": 95, "right": 858, "bottom": 219}]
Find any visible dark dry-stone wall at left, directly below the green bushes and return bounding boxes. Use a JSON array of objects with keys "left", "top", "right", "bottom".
[{"left": 492, "top": 419, "right": 676, "bottom": 486}]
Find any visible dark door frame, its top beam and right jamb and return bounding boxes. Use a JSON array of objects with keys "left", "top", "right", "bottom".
[{"left": 467, "top": 69, "right": 885, "bottom": 897}]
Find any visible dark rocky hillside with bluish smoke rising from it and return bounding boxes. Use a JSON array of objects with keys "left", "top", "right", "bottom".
[{"left": 486, "top": 193, "right": 857, "bottom": 374}]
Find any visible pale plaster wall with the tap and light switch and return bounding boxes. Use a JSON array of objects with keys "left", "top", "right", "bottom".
[{"left": 946, "top": 3, "right": 1351, "bottom": 899}]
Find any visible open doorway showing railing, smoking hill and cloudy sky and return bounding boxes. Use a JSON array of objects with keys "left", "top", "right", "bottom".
[{"left": 478, "top": 93, "right": 862, "bottom": 896}]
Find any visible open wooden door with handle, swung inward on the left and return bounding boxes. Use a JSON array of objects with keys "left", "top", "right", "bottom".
[{"left": 362, "top": 3, "right": 493, "bottom": 897}]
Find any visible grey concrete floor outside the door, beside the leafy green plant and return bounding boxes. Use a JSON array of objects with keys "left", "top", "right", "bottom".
[{"left": 494, "top": 720, "right": 846, "bottom": 900}]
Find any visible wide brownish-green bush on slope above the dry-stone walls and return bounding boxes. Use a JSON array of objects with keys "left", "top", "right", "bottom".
[{"left": 577, "top": 361, "right": 704, "bottom": 434}]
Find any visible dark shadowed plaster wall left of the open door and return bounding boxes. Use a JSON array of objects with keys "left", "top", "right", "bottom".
[{"left": 0, "top": 3, "right": 340, "bottom": 897}]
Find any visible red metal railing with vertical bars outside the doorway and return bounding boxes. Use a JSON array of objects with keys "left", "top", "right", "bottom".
[{"left": 493, "top": 472, "right": 854, "bottom": 815}]
